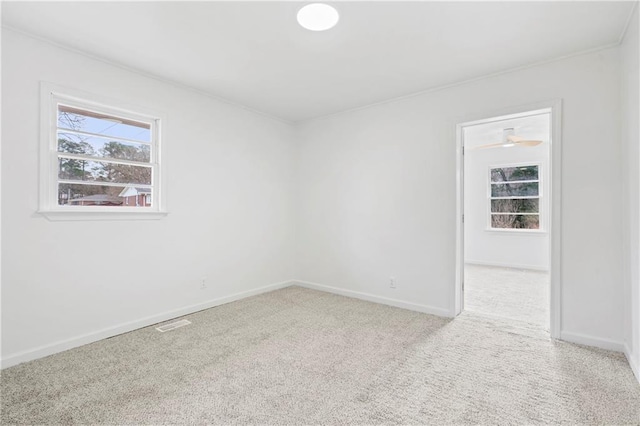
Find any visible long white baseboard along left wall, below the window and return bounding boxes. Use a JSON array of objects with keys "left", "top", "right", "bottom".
[{"left": 0, "top": 280, "right": 294, "bottom": 368}]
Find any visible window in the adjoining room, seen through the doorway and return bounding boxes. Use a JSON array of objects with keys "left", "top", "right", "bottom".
[{"left": 489, "top": 165, "right": 540, "bottom": 229}]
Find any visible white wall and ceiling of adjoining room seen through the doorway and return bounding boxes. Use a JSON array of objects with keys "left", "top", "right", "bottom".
[{"left": 464, "top": 114, "right": 551, "bottom": 271}]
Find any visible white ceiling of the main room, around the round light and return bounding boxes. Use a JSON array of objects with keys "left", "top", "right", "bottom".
[{"left": 2, "top": 1, "right": 634, "bottom": 121}]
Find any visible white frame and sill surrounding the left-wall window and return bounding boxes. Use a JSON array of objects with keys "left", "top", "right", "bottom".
[{"left": 38, "top": 82, "right": 167, "bottom": 220}]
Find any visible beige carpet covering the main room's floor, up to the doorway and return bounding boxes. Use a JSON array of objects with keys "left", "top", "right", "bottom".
[{"left": 1, "top": 287, "right": 640, "bottom": 425}]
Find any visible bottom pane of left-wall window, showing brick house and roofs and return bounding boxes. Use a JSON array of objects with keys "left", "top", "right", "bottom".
[{"left": 58, "top": 183, "right": 151, "bottom": 207}]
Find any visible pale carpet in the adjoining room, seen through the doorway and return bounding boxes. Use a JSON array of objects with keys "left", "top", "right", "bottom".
[{"left": 464, "top": 264, "right": 550, "bottom": 331}]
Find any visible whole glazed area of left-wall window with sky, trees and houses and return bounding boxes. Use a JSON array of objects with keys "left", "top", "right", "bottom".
[{"left": 56, "top": 101, "right": 157, "bottom": 208}]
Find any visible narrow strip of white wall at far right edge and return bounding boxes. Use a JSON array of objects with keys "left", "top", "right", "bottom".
[{"left": 621, "top": 6, "right": 640, "bottom": 380}]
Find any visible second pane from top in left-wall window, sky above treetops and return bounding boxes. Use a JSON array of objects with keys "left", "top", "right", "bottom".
[{"left": 58, "top": 132, "right": 151, "bottom": 163}]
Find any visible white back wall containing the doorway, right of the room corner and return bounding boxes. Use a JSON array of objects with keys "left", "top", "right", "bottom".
[{"left": 297, "top": 49, "right": 624, "bottom": 347}]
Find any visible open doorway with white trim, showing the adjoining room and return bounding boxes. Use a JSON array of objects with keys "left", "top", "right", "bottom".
[{"left": 454, "top": 103, "right": 560, "bottom": 337}]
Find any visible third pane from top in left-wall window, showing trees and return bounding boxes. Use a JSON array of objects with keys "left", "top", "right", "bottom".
[{"left": 58, "top": 157, "right": 151, "bottom": 185}]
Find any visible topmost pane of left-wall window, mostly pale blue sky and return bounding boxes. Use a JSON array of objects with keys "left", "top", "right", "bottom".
[{"left": 58, "top": 105, "right": 151, "bottom": 142}]
